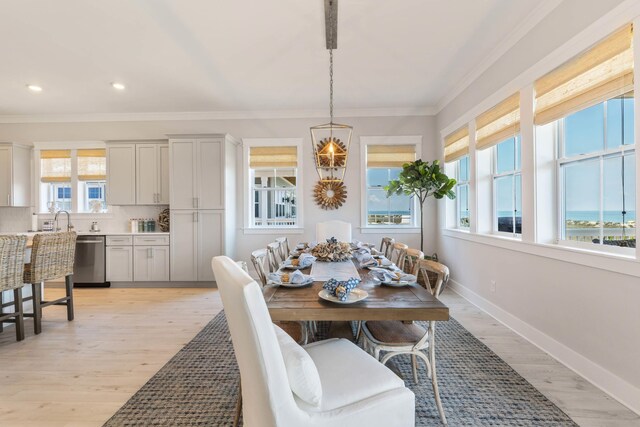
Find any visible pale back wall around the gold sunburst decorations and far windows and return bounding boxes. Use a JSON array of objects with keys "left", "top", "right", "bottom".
[{"left": 0, "top": 116, "right": 438, "bottom": 260}]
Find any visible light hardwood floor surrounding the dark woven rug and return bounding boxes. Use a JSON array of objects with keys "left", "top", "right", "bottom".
[{"left": 0, "top": 288, "right": 640, "bottom": 427}]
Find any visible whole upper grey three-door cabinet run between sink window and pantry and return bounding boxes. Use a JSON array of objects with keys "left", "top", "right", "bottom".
[{"left": 107, "top": 141, "right": 169, "bottom": 205}]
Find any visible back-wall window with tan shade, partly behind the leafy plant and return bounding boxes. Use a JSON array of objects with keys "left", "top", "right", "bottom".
[{"left": 366, "top": 144, "right": 416, "bottom": 227}]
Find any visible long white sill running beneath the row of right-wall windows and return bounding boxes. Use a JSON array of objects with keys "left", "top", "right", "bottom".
[{"left": 442, "top": 229, "right": 640, "bottom": 277}]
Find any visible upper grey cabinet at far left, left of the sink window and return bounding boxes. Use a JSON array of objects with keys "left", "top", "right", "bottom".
[{"left": 0, "top": 144, "right": 32, "bottom": 207}]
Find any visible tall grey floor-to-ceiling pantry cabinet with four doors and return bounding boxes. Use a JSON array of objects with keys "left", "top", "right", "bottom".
[{"left": 169, "top": 134, "right": 238, "bottom": 281}]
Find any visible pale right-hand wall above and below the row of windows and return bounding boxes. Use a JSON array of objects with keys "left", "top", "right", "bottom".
[{"left": 437, "top": 0, "right": 640, "bottom": 412}]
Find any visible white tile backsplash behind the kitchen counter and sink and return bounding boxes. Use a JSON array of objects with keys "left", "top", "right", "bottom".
[{"left": 0, "top": 206, "right": 168, "bottom": 233}]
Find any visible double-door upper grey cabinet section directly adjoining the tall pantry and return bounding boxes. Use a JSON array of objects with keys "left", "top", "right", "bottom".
[{"left": 136, "top": 144, "right": 169, "bottom": 205}]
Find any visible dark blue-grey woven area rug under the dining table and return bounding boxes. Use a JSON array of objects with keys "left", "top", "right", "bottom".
[{"left": 105, "top": 313, "right": 576, "bottom": 427}]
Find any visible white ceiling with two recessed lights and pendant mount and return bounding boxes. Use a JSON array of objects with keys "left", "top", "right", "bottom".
[{"left": 0, "top": 0, "right": 557, "bottom": 118}]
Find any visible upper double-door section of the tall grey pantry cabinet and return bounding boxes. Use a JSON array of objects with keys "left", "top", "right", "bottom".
[{"left": 169, "top": 135, "right": 237, "bottom": 209}]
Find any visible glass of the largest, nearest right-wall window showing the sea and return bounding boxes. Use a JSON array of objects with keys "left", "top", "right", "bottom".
[{"left": 558, "top": 93, "right": 636, "bottom": 247}]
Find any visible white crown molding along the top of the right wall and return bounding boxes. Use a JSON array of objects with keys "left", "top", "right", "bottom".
[{"left": 435, "top": 0, "right": 562, "bottom": 114}]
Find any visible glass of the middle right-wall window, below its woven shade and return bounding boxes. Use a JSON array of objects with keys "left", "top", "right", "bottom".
[{"left": 493, "top": 135, "right": 522, "bottom": 236}]
